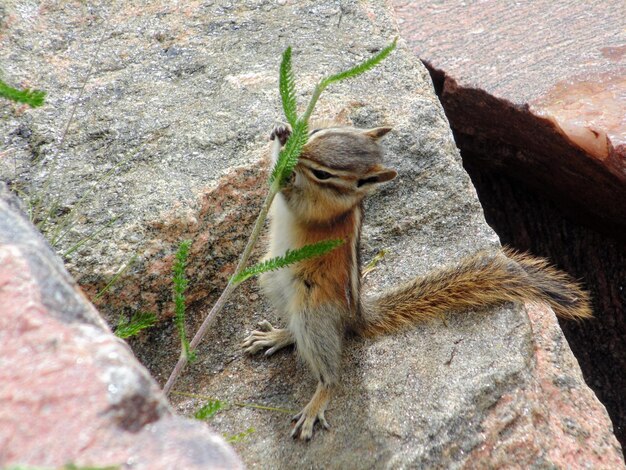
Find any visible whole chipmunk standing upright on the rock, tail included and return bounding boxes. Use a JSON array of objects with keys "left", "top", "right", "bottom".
[{"left": 243, "top": 126, "right": 592, "bottom": 440}]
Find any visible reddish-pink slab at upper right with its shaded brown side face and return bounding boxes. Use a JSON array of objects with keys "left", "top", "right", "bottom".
[{"left": 392, "top": 0, "right": 626, "bottom": 235}]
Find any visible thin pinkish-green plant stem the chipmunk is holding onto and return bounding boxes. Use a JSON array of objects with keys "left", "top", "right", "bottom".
[{"left": 163, "top": 139, "right": 280, "bottom": 396}]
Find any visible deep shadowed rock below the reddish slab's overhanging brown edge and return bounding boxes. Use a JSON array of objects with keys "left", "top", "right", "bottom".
[{"left": 466, "top": 165, "right": 626, "bottom": 446}]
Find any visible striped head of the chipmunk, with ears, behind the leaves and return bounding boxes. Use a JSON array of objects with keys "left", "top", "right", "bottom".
[{"left": 283, "top": 127, "right": 397, "bottom": 223}]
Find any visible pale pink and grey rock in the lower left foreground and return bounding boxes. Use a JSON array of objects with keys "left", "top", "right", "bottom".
[{"left": 0, "top": 185, "right": 241, "bottom": 469}]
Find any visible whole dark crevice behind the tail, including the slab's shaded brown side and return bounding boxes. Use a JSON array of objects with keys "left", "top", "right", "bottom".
[{"left": 426, "top": 64, "right": 626, "bottom": 447}]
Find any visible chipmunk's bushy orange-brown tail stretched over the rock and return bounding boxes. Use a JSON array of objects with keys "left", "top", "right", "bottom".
[{"left": 357, "top": 249, "right": 592, "bottom": 337}]
